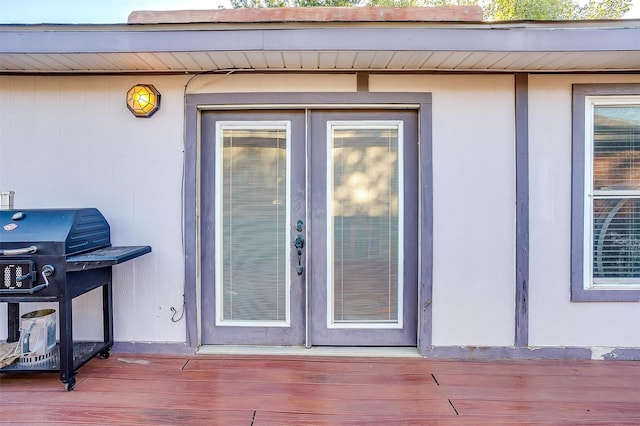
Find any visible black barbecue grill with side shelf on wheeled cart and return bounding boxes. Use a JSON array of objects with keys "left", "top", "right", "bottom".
[{"left": 0, "top": 208, "right": 151, "bottom": 390}]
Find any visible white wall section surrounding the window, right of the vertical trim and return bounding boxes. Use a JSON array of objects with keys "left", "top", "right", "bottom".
[{"left": 529, "top": 75, "right": 640, "bottom": 353}]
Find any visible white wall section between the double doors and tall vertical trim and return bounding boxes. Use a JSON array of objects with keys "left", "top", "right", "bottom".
[{"left": 370, "top": 76, "right": 515, "bottom": 346}]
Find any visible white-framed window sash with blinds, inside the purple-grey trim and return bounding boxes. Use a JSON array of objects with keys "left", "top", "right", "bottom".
[{"left": 585, "top": 97, "right": 640, "bottom": 288}]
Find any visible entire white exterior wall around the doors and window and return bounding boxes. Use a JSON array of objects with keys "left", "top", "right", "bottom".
[{"left": 5, "top": 74, "right": 640, "bottom": 354}]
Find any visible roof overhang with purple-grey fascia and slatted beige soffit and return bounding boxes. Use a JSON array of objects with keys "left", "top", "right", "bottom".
[{"left": 0, "top": 12, "right": 640, "bottom": 74}]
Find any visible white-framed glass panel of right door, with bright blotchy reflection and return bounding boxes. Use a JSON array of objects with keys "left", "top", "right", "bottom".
[{"left": 328, "top": 123, "right": 402, "bottom": 325}]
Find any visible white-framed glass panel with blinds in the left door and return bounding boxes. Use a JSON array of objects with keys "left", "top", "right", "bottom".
[{"left": 216, "top": 124, "right": 289, "bottom": 325}]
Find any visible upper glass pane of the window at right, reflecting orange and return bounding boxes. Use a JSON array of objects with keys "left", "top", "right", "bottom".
[{"left": 593, "top": 105, "right": 640, "bottom": 190}]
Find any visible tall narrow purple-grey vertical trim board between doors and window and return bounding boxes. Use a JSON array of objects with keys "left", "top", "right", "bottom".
[{"left": 514, "top": 73, "right": 529, "bottom": 347}]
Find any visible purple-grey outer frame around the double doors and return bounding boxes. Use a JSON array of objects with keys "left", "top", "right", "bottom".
[{"left": 183, "top": 92, "right": 433, "bottom": 353}]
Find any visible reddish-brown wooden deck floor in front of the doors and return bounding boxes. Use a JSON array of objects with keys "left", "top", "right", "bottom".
[{"left": 0, "top": 353, "right": 640, "bottom": 426}]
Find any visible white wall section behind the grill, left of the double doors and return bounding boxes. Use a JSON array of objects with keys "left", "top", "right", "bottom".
[{"left": 0, "top": 76, "right": 186, "bottom": 342}]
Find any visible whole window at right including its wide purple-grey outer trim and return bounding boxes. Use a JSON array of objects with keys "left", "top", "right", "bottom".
[{"left": 572, "top": 85, "right": 640, "bottom": 301}]
